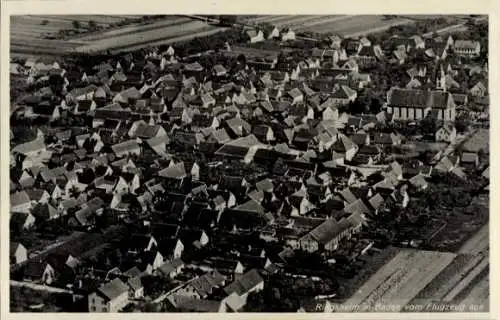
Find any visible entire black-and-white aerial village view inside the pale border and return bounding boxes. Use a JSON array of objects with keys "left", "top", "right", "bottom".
[{"left": 9, "top": 14, "right": 490, "bottom": 313}]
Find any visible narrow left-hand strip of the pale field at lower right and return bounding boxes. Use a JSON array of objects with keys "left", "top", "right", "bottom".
[{"left": 346, "top": 251, "right": 414, "bottom": 305}]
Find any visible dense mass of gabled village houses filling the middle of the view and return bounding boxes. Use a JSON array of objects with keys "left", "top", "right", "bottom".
[{"left": 10, "top": 24, "right": 487, "bottom": 312}]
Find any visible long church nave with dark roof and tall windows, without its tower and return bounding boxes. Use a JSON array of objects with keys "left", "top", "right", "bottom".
[{"left": 387, "top": 88, "right": 456, "bottom": 121}]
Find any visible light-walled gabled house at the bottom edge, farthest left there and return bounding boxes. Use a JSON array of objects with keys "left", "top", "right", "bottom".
[{"left": 88, "top": 278, "right": 129, "bottom": 312}]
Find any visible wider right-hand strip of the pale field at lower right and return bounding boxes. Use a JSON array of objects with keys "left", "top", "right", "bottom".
[{"left": 378, "top": 251, "right": 455, "bottom": 311}]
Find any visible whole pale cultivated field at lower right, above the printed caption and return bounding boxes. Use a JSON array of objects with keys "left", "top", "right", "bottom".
[{"left": 344, "top": 249, "right": 456, "bottom": 312}]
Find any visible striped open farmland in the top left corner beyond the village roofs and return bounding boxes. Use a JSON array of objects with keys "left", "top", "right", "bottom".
[{"left": 10, "top": 15, "right": 203, "bottom": 55}]
